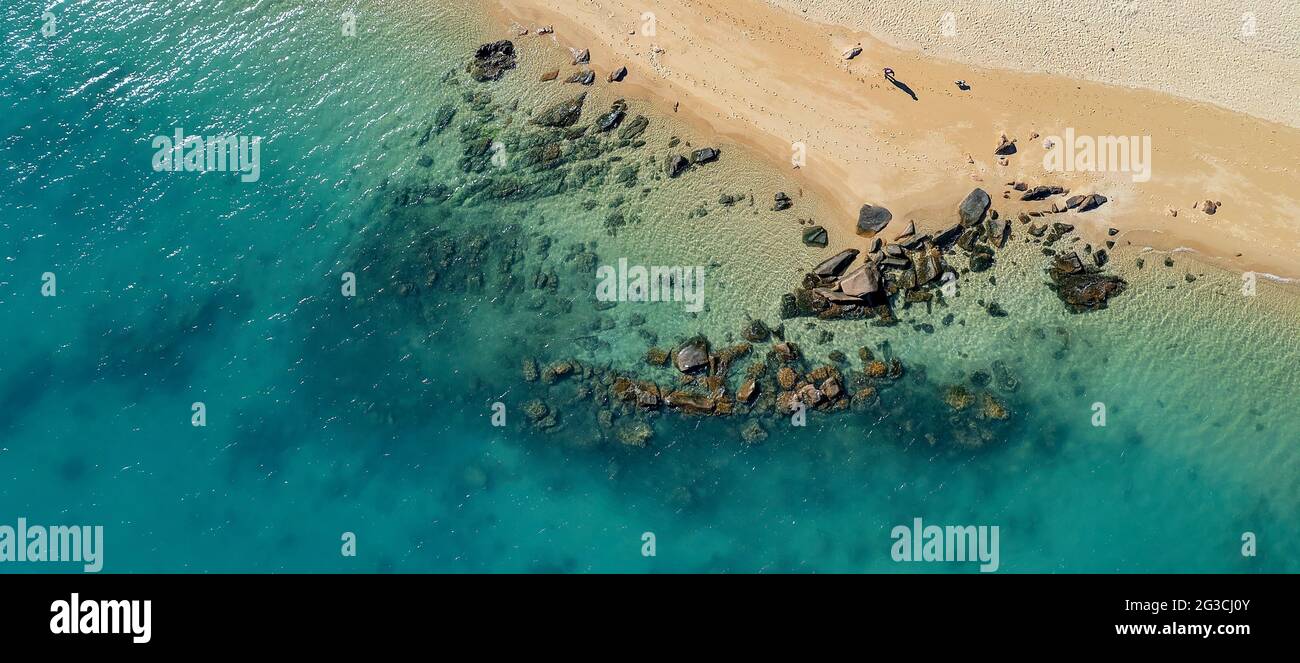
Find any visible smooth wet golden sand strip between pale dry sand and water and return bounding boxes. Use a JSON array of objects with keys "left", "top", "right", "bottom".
[{"left": 488, "top": 0, "right": 1300, "bottom": 278}]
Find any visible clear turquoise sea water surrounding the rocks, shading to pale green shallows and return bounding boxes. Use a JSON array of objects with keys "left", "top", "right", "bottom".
[{"left": 0, "top": 0, "right": 1300, "bottom": 572}]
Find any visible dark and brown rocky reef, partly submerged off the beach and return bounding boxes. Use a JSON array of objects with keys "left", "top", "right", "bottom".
[{"left": 367, "top": 43, "right": 1144, "bottom": 449}]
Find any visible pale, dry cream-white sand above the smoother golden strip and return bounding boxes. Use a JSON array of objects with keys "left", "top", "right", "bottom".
[{"left": 766, "top": 0, "right": 1300, "bottom": 126}]
